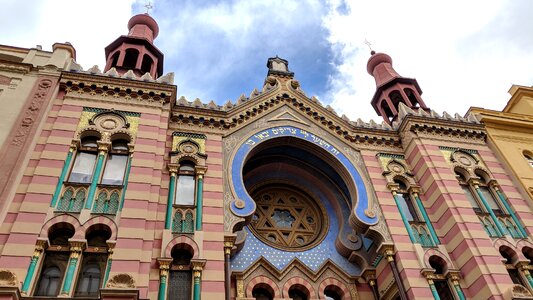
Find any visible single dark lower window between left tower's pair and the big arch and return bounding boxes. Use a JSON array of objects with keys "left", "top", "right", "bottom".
[{"left": 167, "top": 246, "right": 192, "bottom": 300}]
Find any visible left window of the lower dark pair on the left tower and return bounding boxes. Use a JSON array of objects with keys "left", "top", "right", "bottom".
[{"left": 34, "top": 223, "right": 74, "bottom": 297}]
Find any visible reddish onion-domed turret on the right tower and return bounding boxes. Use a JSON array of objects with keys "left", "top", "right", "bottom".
[{"left": 366, "top": 51, "right": 429, "bottom": 124}]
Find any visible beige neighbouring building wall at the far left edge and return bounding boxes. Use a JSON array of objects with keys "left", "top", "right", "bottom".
[{"left": 0, "top": 43, "right": 75, "bottom": 230}]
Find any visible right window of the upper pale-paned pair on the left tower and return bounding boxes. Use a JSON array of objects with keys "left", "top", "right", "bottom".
[{"left": 102, "top": 139, "right": 129, "bottom": 185}]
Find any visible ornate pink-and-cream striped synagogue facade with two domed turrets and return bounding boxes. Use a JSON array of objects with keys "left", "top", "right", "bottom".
[{"left": 0, "top": 14, "right": 533, "bottom": 300}]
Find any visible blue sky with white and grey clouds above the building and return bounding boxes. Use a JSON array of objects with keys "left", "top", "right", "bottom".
[{"left": 0, "top": 0, "right": 533, "bottom": 121}]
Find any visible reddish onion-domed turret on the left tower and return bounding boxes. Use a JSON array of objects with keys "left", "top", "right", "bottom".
[{"left": 104, "top": 14, "right": 163, "bottom": 79}]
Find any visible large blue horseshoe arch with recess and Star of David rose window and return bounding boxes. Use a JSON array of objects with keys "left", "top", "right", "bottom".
[{"left": 227, "top": 126, "right": 382, "bottom": 298}]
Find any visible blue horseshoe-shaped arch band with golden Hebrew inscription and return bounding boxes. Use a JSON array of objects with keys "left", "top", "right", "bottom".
[{"left": 231, "top": 126, "right": 378, "bottom": 225}]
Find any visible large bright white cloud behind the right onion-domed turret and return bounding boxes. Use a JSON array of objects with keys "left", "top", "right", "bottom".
[{"left": 324, "top": 0, "right": 533, "bottom": 120}]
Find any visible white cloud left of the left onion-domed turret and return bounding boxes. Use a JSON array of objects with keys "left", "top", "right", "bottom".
[{"left": 0, "top": 0, "right": 134, "bottom": 68}]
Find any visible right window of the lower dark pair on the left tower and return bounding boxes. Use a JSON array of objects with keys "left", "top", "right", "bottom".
[{"left": 75, "top": 229, "right": 111, "bottom": 297}]
